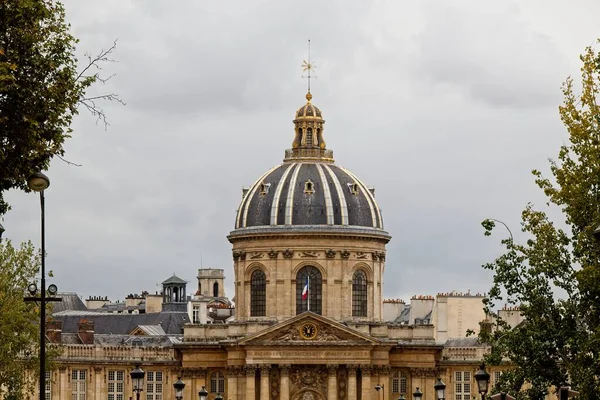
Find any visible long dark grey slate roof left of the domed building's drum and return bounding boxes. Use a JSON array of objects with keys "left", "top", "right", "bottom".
[{"left": 52, "top": 311, "right": 190, "bottom": 335}]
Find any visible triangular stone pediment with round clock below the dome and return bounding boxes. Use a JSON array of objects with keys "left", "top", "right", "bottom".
[{"left": 238, "top": 312, "right": 379, "bottom": 346}]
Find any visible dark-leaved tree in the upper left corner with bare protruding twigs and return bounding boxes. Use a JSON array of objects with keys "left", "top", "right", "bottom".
[{"left": 0, "top": 0, "right": 121, "bottom": 216}]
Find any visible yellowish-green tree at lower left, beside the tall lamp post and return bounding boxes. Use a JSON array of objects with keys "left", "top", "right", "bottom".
[{"left": 0, "top": 240, "right": 40, "bottom": 399}]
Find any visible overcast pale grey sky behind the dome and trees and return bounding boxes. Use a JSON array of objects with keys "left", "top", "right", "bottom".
[{"left": 2, "top": 0, "right": 600, "bottom": 300}]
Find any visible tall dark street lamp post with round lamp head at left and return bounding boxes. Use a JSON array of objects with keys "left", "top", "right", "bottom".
[{"left": 23, "top": 172, "right": 62, "bottom": 400}]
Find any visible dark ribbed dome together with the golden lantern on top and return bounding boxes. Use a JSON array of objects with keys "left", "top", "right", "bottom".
[{"left": 235, "top": 92, "right": 383, "bottom": 230}]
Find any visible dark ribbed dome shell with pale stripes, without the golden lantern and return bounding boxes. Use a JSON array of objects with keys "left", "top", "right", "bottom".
[{"left": 235, "top": 162, "right": 383, "bottom": 229}]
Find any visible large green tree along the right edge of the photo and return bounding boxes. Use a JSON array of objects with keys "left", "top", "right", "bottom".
[{"left": 480, "top": 43, "right": 600, "bottom": 399}]
